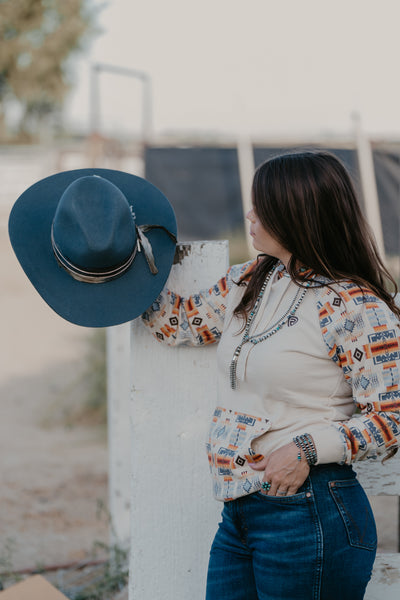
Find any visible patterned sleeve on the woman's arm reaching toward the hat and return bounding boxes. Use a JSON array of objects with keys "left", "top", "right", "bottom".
[{"left": 142, "top": 260, "right": 256, "bottom": 346}]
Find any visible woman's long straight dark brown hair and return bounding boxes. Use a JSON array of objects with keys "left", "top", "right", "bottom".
[{"left": 234, "top": 152, "right": 400, "bottom": 319}]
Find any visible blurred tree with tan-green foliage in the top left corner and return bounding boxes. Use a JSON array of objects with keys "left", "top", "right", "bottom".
[{"left": 0, "top": 0, "right": 99, "bottom": 137}]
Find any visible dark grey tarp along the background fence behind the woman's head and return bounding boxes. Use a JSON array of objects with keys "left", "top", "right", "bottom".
[{"left": 145, "top": 146, "right": 400, "bottom": 255}]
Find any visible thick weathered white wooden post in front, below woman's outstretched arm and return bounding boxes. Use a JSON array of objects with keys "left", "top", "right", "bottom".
[{"left": 129, "top": 242, "right": 228, "bottom": 600}]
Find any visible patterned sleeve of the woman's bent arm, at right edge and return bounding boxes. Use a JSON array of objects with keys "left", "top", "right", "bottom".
[{"left": 318, "top": 283, "right": 400, "bottom": 464}]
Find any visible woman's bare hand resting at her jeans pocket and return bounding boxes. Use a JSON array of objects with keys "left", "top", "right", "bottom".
[{"left": 249, "top": 442, "right": 310, "bottom": 496}]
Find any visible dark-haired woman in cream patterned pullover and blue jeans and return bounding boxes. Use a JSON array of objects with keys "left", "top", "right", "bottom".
[{"left": 143, "top": 152, "right": 400, "bottom": 600}]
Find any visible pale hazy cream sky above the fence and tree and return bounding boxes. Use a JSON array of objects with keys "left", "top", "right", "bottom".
[{"left": 66, "top": 0, "right": 400, "bottom": 139}]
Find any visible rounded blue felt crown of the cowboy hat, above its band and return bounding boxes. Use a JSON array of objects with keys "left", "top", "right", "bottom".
[{"left": 53, "top": 175, "right": 136, "bottom": 270}]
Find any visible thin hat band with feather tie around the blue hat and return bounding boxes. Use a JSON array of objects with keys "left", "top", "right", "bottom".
[{"left": 51, "top": 225, "right": 176, "bottom": 283}]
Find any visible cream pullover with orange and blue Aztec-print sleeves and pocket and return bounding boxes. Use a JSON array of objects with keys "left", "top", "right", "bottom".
[{"left": 142, "top": 261, "right": 400, "bottom": 500}]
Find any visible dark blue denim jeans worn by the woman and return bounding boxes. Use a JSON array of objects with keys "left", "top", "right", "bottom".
[{"left": 206, "top": 464, "right": 377, "bottom": 600}]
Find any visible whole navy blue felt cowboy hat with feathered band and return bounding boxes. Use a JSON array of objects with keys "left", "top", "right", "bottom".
[{"left": 9, "top": 169, "right": 176, "bottom": 327}]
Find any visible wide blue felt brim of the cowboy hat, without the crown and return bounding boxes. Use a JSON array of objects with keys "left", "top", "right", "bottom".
[{"left": 9, "top": 169, "right": 176, "bottom": 327}]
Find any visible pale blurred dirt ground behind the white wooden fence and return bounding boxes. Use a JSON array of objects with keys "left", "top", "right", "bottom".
[{"left": 0, "top": 192, "right": 398, "bottom": 571}]
